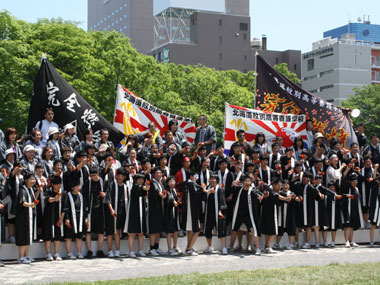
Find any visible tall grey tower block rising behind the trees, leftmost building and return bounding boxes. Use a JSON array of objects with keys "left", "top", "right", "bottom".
[{"left": 87, "top": 0, "right": 153, "bottom": 53}]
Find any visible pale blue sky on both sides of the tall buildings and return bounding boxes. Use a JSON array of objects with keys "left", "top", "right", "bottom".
[{"left": 0, "top": 0, "right": 380, "bottom": 52}]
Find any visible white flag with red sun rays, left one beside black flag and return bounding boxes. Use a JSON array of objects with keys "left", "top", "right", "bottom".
[{"left": 113, "top": 84, "right": 197, "bottom": 144}]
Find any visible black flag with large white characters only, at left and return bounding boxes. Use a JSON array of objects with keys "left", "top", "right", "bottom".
[{"left": 28, "top": 59, "right": 124, "bottom": 145}]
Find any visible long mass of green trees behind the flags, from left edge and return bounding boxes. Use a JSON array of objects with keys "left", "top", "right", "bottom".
[{"left": 0, "top": 12, "right": 255, "bottom": 138}]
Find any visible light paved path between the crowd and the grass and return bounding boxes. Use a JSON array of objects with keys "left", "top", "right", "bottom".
[{"left": 0, "top": 246, "right": 380, "bottom": 284}]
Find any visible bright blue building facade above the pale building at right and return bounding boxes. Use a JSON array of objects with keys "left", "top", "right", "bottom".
[{"left": 323, "top": 22, "right": 380, "bottom": 44}]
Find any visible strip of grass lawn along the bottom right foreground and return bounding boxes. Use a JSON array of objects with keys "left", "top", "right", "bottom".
[{"left": 55, "top": 263, "right": 380, "bottom": 285}]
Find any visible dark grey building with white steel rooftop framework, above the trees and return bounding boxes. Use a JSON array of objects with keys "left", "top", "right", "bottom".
[{"left": 148, "top": 0, "right": 301, "bottom": 77}]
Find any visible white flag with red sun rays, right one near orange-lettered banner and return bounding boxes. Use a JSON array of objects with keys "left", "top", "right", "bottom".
[{"left": 224, "top": 103, "right": 307, "bottom": 153}]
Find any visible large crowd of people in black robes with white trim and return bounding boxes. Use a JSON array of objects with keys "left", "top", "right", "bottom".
[{"left": 0, "top": 108, "right": 380, "bottom": 265}]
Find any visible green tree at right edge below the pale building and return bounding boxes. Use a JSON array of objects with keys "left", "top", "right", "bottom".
[{"left": 342, "top": 85, "right": 380, "bottom": 135}]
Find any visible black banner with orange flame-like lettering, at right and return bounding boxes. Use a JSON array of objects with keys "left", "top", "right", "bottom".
[{"left": 255, "top": 55, "right": 357, "bottom": 147}]
